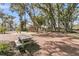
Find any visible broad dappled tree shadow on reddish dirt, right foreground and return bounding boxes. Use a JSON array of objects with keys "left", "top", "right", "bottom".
[{"left": 43, "top": 41, "right": 79, "bottom": 56}]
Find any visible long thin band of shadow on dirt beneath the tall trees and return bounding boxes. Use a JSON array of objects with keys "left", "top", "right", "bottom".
[{"left": 32, "top": 32, "right": 79, "bottom": 39}]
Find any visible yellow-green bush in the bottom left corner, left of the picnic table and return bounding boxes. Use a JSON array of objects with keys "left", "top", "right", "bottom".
[{"left": 0, "top": 41, "right": 15, "bottom": 56}]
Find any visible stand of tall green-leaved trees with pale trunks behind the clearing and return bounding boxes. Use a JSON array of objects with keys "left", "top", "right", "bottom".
[{"left": 11, "top": 3, "right": 78, "bottom": 32}]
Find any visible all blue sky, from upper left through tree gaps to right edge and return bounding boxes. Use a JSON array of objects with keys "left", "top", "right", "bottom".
[{"left": 0, "top": 3, "right": 79, "bottom": 24}]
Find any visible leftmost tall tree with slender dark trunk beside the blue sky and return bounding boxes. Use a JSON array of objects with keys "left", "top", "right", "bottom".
[{"left": 11, "top": 3, "right": 25, "bottom": 31}]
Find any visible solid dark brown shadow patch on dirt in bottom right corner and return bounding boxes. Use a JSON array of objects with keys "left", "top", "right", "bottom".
[{"left": 55, "top": 42, "right": 79, "bottom": 56}]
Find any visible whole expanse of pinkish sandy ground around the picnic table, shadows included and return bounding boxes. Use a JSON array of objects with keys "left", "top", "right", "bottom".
[{"left": 0, "top": 32, "right": 79, "bottom": 56}]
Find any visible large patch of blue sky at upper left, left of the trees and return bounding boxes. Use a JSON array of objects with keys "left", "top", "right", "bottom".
[{"left": 0, "top": 4, "right": 19, "bottom": 23}]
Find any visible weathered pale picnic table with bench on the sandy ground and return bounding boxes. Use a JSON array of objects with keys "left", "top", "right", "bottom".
[{"left": 15, "top": 35, "right": 34, "bottom": 52}]
